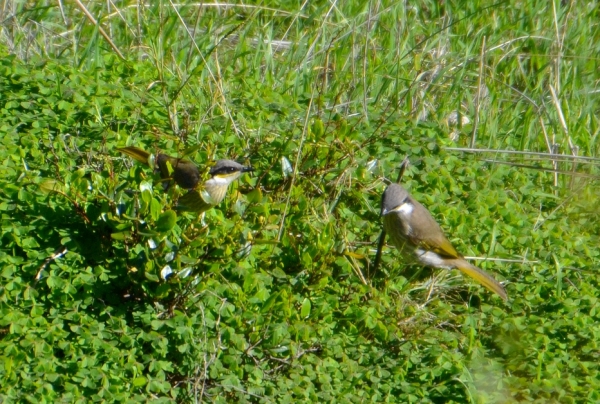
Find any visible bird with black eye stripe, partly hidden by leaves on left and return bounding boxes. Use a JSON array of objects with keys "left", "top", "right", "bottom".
[{"left": 117, "top": 146, "right": 254, "bottom": 214}]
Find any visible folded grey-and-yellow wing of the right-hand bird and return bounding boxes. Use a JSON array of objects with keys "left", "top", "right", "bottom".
[{"left": 408, "top": 197, "right": 461, "bottom": 258}]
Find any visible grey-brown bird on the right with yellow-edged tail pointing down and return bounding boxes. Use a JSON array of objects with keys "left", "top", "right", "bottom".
[{"left": 381, "top": 183, "right": 508, "bottom": 301}]
